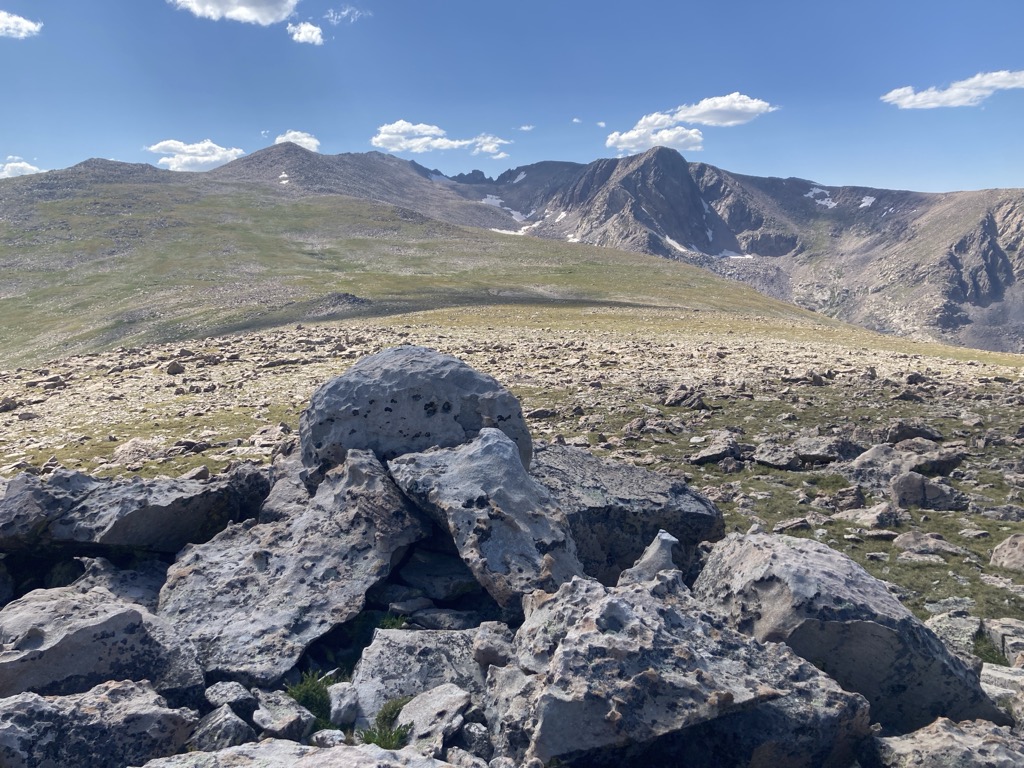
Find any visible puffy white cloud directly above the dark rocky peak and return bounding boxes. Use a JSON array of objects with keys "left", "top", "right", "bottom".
[{"left": 604, "top": 92, "right": 778, "bottom": 153}]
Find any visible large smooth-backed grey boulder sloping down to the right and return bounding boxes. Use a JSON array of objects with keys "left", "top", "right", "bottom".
[{"left": 693, "top": 535, "right": 1008, "bottom": 733}]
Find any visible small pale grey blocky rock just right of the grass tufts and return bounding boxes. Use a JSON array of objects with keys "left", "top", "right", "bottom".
[{"left": 351, "top": 630, "right": 483, "bottom": 728}]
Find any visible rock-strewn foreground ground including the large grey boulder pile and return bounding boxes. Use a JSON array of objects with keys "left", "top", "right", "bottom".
[{"left": 0, "top": 321, "right": 1024, "bottom": 768}]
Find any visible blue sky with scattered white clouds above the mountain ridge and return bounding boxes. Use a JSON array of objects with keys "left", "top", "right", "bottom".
[{"left": 0, "top": 0, "right": 1024, "bottom": 191}]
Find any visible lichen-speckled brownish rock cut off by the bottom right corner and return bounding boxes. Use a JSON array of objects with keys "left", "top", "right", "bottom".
[{"left": 861, "top": 718, "right": 1024, "bottom": 768}]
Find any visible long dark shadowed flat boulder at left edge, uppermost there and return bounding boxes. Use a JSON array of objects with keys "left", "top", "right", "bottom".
[{"left": 0, "top": 464, "right": 269, "bottom": 554}]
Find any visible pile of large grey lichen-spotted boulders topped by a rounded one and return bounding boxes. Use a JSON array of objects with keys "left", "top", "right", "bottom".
[{"left": 0, "top": 347, "right": 1024, "bottom": 768}]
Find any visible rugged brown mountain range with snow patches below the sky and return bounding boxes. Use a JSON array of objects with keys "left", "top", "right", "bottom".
[{"left": 0, "top": 143, "right": 1024, "bottom": 352}]
